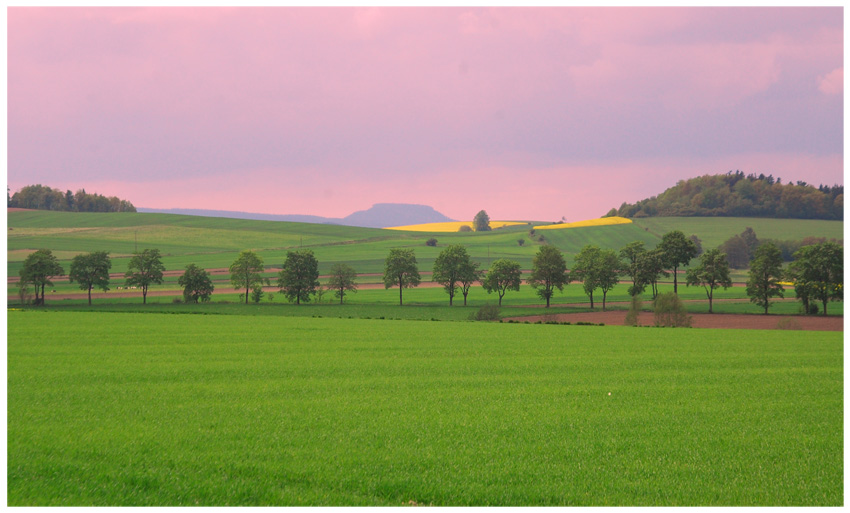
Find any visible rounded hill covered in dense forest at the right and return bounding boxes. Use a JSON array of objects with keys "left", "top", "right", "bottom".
[{"left": 605, "top": 171, "right": 844, "bottom": 220}]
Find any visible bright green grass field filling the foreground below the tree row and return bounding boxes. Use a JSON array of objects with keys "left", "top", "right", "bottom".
[{"left": 7, "top": 310, "right": 843, "bottom": 506}]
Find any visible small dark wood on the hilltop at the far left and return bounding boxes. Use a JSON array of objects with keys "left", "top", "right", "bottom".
[{"left": 6, "top": 185, "right": 136, "bottom": 212}]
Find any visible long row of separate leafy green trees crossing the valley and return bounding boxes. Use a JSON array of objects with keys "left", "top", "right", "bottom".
[{"left": 20, "top": 230, "right": 844, "bottom": 315}]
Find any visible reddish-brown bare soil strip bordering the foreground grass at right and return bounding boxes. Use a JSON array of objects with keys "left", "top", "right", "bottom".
[{"left": 505, "top": 310, "right": 844, "bottom": 331}]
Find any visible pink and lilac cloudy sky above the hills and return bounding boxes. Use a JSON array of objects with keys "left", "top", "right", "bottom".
[{"left": 7, "top": 7, "right": 844, "bottom": 220}]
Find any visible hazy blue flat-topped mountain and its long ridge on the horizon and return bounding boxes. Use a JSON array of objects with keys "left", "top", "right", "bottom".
[{"left": 137, "top": 203, "right": 454, "bottom": 228}]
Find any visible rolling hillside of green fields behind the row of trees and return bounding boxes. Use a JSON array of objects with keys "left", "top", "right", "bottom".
[{"left": 7, "top": 211, "right": 843, "bottom": 277}]
